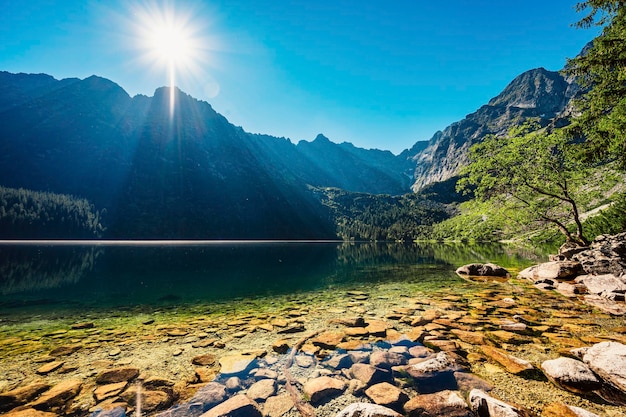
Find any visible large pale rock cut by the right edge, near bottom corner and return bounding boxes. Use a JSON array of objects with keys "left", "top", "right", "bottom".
[{"left": 583, "top": 342, "right": 626, "bottom": 393}]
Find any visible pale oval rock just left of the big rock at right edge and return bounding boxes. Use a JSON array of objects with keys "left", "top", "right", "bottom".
[{"left": 541, "top": 357, "right": 602, "bottom": 394}]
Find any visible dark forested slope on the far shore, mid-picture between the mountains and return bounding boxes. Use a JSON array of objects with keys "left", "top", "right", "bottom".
[{"left": 317, "top": 188, "right": 451, "bottom": 242}]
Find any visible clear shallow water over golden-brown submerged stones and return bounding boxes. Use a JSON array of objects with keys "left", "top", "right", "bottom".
[{"left": 0, "top": 272, "right": 626, "bottom": 417}]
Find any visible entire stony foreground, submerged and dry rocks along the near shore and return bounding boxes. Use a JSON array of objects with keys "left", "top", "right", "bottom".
[{"left": 0, "top": 237, "right": 626, "bottom": 417}]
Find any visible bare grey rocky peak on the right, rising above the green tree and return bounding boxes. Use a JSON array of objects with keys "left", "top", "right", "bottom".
[{"left": 402, "top": 68, "right": 580, "bottom": 191}]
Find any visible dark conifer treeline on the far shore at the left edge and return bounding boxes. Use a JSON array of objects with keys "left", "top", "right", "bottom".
[{"left": 0, "top": 186, "right": 104, "bottom": 239}]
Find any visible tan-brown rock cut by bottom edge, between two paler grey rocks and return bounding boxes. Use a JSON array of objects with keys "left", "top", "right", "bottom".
[{"left": 404, "top": 390, "right": 474, "bottom": 417}]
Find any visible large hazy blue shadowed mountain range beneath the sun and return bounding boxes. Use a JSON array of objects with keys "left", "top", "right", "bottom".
[{"left": 0, "top": 72, "right": 409, "bottom": 239}]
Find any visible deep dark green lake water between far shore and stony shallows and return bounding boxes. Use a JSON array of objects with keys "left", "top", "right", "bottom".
[{"left": 0, "top": 242, "right": 541, "bottom": 319}]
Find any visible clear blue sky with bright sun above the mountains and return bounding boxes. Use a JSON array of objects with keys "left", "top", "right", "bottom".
[{"left": 0, "top": 0, "right": 598, "bottom": 153}]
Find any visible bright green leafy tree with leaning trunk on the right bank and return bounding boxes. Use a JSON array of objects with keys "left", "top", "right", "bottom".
[{"left": 457, "top": 123, "right": 589, "bottom": 245}]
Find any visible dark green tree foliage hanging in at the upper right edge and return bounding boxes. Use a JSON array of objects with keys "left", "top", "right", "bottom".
[{"left": 566, "top": 0, "right": 626, "bottom": 168}]
